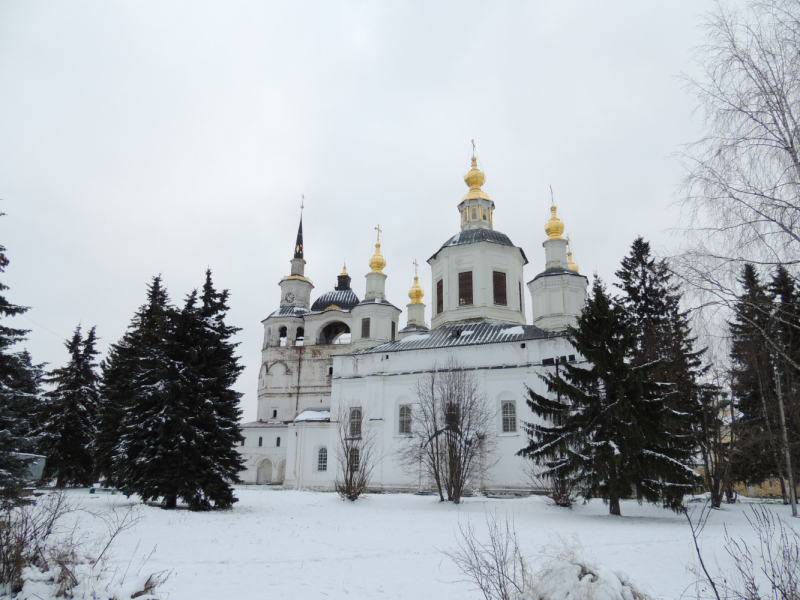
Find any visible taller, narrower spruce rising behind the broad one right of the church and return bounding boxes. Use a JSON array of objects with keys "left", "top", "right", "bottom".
[{"left": 615, "top": 236, "right": 715, "bottom": 504}]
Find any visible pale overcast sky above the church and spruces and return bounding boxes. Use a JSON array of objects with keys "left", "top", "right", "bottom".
[{"left": 0, "top": 0, "right": 711, "bottom": 420}]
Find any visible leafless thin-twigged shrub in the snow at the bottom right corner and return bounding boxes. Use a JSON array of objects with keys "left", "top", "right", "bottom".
[{"left": 686, "top": 504, "right": 800, "bottom": 600}]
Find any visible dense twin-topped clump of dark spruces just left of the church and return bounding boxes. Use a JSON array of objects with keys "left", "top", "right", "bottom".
[{"left": 108, "top": 272, "right": 242, "bottom": 509}]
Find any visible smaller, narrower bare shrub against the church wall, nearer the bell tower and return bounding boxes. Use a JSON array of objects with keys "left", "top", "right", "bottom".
[{"left": 334, "top": 403, "right": 380, "bottom": 501}]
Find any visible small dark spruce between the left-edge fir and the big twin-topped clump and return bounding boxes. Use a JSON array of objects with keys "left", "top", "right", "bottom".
[{"left": 39, "top": 325, "right": 99, "bottom": 487}]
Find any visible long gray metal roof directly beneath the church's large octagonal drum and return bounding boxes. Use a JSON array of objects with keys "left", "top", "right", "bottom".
[{"left": 353, "top": 323, "right": 564, "bottom": 354}]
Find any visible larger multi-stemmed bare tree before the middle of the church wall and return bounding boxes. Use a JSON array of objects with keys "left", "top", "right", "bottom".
[{"left": 399, "top": 359, "right": 497, "bottom": 504}]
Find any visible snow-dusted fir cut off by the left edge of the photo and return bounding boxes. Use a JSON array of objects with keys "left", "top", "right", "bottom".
[{"left": 0, "top": 234, "right": 42, "bottom": 500}]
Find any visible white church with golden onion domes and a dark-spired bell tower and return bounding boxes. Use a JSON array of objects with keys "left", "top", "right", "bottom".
[{"left": 239, "top": 157, "right": 588, "bottom": 491}]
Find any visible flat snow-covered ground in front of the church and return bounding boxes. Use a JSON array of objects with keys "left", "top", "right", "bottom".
[{"left": 18, "top": 487, "right": 793, "bottom": 600}]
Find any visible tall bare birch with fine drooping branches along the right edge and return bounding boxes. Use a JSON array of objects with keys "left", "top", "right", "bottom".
[{"left": 672, "top": 0, "right": 800, "bottom": 511}]
